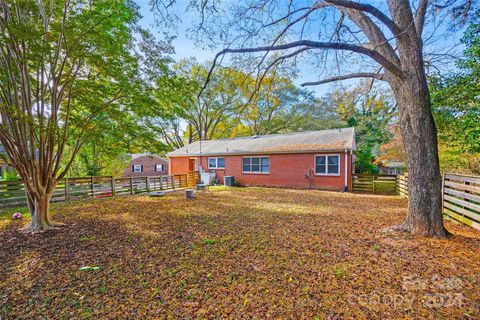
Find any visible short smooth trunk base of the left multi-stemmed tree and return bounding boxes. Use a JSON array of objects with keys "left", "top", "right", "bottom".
[{"left": 21, "top": 193, "right": 61, "bottom": 233}]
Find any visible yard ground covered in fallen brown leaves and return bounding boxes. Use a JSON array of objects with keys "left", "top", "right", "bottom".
[{"left": 0, "top": 188, "right": 480, "bottom": 319}]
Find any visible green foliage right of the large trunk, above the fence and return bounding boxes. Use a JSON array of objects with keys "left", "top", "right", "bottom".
[{"left": 430, "top": 11, "right": 480, "bottom": 174}]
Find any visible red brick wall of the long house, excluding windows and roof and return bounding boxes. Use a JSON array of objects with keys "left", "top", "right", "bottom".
[{"left": 170, "top": 152, "right": 352, "bottom": 191}]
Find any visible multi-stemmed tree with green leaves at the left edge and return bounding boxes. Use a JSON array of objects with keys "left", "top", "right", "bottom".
[{"left": 0, "top": 0, "right": 159, "bottom": 232}]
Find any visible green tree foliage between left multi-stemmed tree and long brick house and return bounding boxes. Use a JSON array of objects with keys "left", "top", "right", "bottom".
[{"left": 59, "top": 6, "right": 174, "bottom": 176}]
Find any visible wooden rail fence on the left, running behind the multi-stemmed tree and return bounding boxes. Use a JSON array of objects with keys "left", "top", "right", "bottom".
[{"left": 0, "top": 171, "right": 200, "bottom": 210}]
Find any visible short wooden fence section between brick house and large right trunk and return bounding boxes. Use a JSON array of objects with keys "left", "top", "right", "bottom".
[{"left": 352, "top": 173, "right": 397, "bottom": 194}]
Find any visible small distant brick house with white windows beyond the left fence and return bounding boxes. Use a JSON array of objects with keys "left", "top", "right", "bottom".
[{"left": 122, "top": 154, "right": 168, "bottom": 177}]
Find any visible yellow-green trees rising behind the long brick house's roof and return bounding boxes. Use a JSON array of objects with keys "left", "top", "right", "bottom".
[{"left": 147, "top": 59, "right": 318, "bottom": 149}]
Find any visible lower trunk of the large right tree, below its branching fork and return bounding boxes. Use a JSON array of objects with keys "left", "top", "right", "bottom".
[{"left": 392, "top": 73, "right": 449, "bottom": 238}]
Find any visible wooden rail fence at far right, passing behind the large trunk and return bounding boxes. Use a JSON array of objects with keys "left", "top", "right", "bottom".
[{"left": 398, "top": 174, "right": 480, "bottom": 229}]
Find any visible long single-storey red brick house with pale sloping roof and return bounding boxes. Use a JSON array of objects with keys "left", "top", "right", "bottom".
[{"left": 167, "top": 128, "right": 355, "bottom": 191}]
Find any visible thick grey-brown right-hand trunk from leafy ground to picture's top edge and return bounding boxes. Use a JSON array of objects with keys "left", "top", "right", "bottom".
[{"left": 388, "top": 0, "right": 449, "bottom": 238}]
